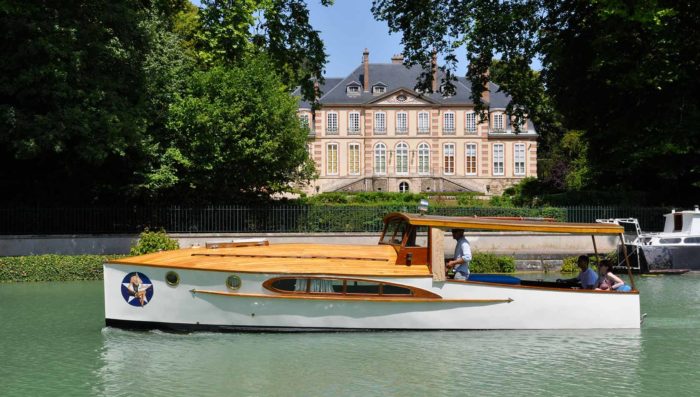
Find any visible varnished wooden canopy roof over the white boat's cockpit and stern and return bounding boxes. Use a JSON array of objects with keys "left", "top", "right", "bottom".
[{"left": 384, "top": 212, "right": 625, "bottom": 235}]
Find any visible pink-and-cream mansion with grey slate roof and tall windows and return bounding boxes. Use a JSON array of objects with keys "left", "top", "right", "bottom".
[{"left": 295, "top": 50, "right": 537, "bottom": 195}]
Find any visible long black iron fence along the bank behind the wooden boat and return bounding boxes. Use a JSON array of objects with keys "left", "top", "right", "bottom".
[{"left": 0, "top": 205, "right": 669, "bottom": 235}]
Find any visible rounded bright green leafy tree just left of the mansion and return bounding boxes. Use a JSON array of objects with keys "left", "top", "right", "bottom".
[{"left": 148, "top": 55, "right": 313, "bottom": 203}]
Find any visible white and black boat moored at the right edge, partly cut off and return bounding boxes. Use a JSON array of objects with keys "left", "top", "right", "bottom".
[{"left": 596, "top": 205, "right": 700, "bottom": 274}]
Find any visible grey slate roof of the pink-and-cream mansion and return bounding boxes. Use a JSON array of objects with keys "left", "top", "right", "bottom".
[{"left": 294, "top": 63, "right": 509, "bottom": 109}]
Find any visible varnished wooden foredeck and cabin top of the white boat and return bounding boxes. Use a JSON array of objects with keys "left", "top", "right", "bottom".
[{"left": 109, "top": 244, "right": 432, "bottom": 277}]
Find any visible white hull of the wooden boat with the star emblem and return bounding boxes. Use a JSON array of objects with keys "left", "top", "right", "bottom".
[{"left": 104, "top": 264, "right": 640, "bottom": 331}]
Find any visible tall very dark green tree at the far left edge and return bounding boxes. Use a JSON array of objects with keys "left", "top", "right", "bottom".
[{"left": 0, "top": 0, "right": 158, "bottom": 202}]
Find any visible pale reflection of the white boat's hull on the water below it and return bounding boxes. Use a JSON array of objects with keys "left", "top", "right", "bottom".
[{"left": 96, "top": 329, "right": 641, "bottom": 396}]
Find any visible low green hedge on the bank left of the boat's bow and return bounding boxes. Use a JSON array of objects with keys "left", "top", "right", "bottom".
[{"left": 0, "top": 255, "right": 118, "bottom": 282}]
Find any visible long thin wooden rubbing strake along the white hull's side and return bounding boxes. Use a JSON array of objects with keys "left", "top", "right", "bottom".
[{"left": 190, "top": 289, "right": 513, "bottom": 304}]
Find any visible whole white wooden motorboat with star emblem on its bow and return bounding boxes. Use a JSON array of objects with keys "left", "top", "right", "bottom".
[{"left": 104, "top": 212, "right": 640, "bottom": 332}]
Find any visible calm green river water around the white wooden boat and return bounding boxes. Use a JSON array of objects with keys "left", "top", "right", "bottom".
[{"left": 0, "top": 274, "right": 700, "bottom": 397}]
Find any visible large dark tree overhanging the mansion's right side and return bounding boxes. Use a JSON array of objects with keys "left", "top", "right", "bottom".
[{"left": 373, "top": 0, "right": 700, "bottom": 204}]
